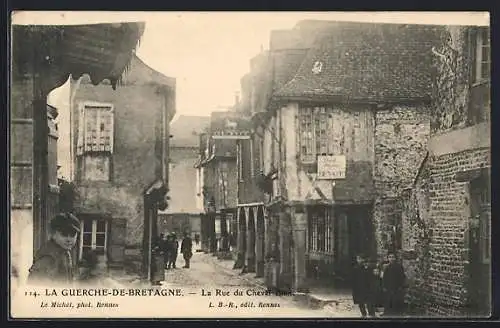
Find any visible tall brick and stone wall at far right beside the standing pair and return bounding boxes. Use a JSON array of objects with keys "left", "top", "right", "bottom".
[{"left": 412, "top": 27, "right": 490, "bottom": 316}]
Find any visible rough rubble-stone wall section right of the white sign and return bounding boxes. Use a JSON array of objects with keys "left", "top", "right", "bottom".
[{"left": 373, "top": 104, "right": 430, "bottom": 256}]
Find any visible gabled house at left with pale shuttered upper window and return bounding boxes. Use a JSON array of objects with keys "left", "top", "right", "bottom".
[{"left": 71, "top": 55, "right": 176, "bottom": 277}]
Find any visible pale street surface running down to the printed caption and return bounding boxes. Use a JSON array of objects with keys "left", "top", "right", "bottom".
[{"left": 155, "top": 253, "right": 356, "bottom": 318}]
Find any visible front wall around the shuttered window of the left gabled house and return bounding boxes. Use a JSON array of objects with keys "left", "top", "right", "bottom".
[{"left": 72, "top": 83, "right": 163, "bottom": 247}]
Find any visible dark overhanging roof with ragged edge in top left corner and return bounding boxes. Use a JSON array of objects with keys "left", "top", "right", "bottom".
[{"left": 12, "top": 22, "right": 145, "bottom": 91}]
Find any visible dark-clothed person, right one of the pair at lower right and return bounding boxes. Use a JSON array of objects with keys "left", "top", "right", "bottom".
[{"left": 382, "top": 253, "right": 406, "bottom": 316}]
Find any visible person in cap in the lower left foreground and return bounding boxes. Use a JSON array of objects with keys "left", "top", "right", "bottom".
[{"left": 28, "top": 213, "right": 80, "bottom": 286}]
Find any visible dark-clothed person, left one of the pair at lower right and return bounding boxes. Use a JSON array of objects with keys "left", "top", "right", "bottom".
[{"left": 352, "top": 255, "right": 375, "bottom": 317}]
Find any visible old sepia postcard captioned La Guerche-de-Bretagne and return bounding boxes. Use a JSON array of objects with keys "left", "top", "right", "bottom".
[{"left": 8, "top": 11, "right": 491, "bottom": 320}]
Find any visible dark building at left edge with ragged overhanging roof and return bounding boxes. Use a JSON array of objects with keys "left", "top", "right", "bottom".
[{"left": 9, "top": 23, "right": 144, "bottom": 284}]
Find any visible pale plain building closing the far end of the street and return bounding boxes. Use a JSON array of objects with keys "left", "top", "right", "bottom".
[{"left": 159, "top": 115, "right": 210, "bottom": 237}]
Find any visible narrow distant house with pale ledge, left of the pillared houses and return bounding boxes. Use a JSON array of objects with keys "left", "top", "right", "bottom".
[{"left": 196, "top": 110, "right": 250, "bottom": 257}]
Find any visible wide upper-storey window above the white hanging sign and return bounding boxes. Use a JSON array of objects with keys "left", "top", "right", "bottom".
[{"left": 298, "top": 106, "right": 345, "bottom": 163}]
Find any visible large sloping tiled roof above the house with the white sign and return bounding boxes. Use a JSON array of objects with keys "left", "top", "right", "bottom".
[{"left": 274, "top": 22, "right": 444, "bottom": 100}]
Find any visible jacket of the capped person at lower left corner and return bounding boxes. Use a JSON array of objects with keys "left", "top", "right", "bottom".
[{"left": 28, "top": 239, "right": 74, "bottom": 286}]
